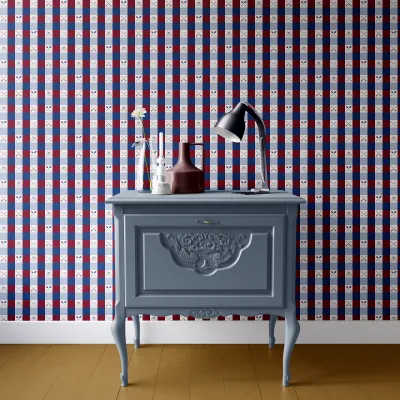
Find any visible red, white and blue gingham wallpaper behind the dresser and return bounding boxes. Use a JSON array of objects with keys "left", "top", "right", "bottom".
[{"left": 0, "top": 0, "right": 399, "bottom": 320}]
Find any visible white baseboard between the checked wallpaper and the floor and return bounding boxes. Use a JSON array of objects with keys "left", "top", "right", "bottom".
[{"left": 0, "top": 321, "right": 400, "bottom": 344}]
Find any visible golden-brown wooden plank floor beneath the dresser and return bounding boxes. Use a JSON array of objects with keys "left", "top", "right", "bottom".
[{"left": 0, "top": 345, "right": 400, "bottom": 400}]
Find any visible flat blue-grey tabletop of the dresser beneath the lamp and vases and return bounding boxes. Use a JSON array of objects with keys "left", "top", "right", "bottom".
[{"left": 106, "top": 190, "right": 306, "bottom": 204}]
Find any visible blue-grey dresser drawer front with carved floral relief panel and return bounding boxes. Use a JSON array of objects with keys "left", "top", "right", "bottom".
[{"left": 125, "top": 214, "right": 285, "bottom": 307}]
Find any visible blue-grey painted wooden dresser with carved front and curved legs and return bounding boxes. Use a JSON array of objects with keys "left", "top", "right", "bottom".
[{"left": 107, "top": 191, "right": 305, "bottom": 386}]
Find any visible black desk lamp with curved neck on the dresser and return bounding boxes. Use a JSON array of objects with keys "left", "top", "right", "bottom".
[{"left": 214, "top": 103, "right": 269, "bottom": 194}]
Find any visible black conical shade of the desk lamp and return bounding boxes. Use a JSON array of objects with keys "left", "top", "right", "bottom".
[{"left": 214, "top": 103, "right": 246, "bottom": 143}]
